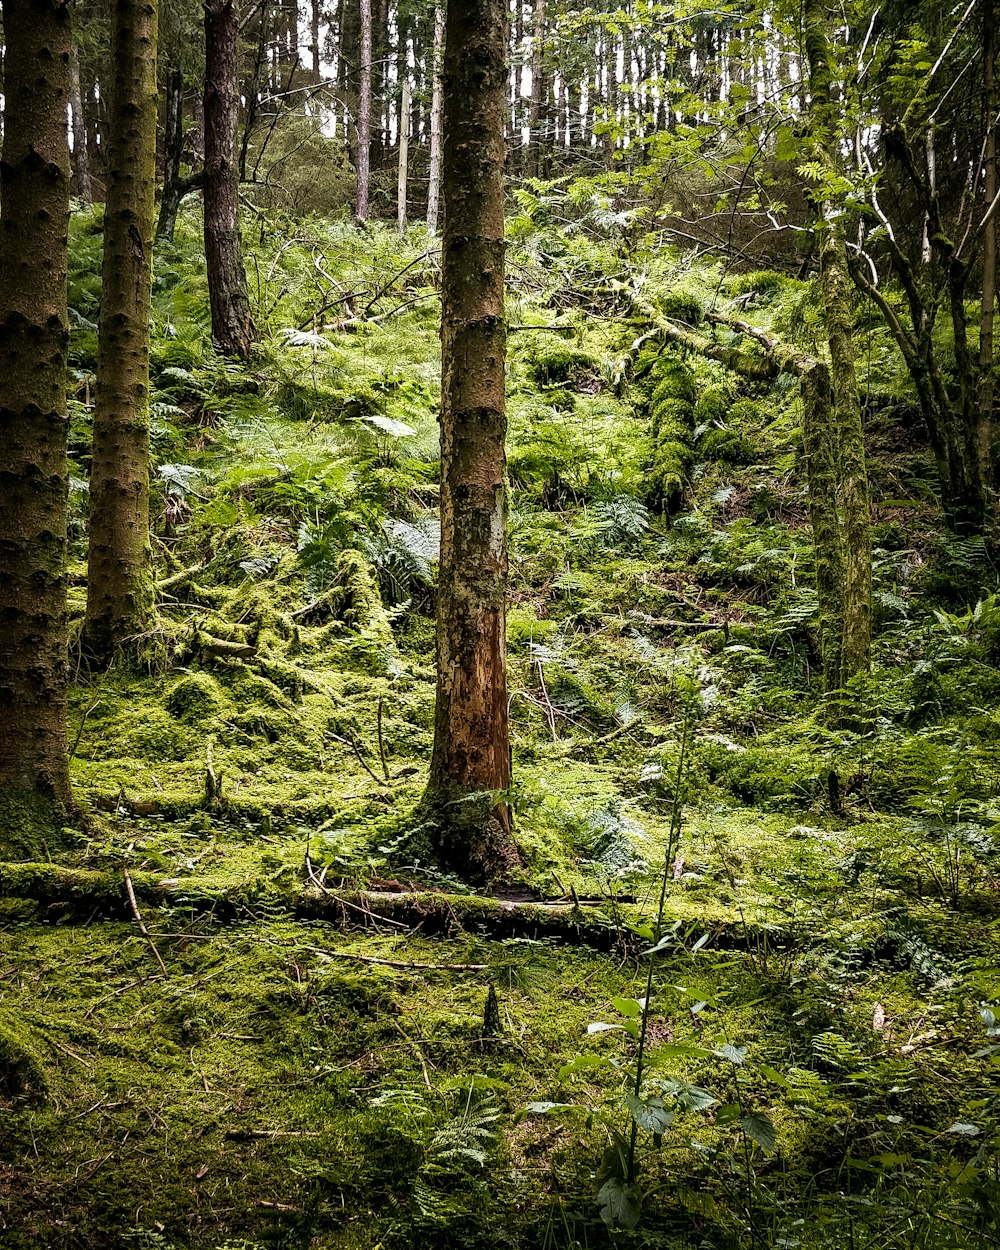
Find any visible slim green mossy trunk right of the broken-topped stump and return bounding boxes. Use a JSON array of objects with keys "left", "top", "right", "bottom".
[{"left": 803, "top": 0, "right": 871, "bottom": 691}]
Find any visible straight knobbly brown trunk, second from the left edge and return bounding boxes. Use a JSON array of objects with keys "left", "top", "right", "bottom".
[{"left": 84, "top": 0, "right": 158, "bottom": 666}]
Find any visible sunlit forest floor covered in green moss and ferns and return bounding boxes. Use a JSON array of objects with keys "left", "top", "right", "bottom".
[{"left": 0, "top": 210, "right": 1000, "bottom": 1250}]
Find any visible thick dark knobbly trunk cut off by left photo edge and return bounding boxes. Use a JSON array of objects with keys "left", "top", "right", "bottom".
[{"left": 0, "top": 0, "right": 73, "bottom": 858}]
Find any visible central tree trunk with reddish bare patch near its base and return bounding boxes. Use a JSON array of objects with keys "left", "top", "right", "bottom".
[{"left": 426, "top": 0, "right": 516, "bottom": 880}]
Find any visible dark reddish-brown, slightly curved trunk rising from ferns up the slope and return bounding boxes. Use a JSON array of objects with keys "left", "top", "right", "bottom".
[{"left": 205, "top": 0, "right": 258, "bottom": 359}]
